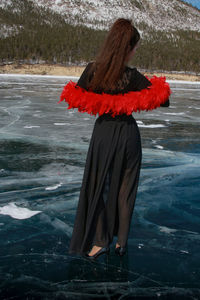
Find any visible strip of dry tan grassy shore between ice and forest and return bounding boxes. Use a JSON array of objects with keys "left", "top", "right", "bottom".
[{"left": 0, "top": 64, "right": 200, "bottom": 82}]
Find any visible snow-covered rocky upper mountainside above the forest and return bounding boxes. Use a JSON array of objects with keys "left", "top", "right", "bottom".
[{"left": 0, "top": 0, "right": 200, "bottom": 33}]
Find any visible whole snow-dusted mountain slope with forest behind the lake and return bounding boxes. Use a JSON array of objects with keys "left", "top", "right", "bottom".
[{"left": 0, "top": 0, "right": 200, "bottom": 72}]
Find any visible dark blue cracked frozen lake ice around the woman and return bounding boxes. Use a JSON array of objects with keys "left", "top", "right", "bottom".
[{"left": 0, "top": 75, "right": 200, "bottom": 300}]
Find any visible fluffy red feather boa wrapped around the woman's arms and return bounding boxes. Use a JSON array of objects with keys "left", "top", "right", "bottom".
[{"left": 58, "top": 75, "right": 171, "bottom": 117}]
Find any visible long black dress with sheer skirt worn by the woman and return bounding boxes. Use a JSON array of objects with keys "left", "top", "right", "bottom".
[{"left": 69, "top": 63, "right": 169, "bottom": 255}]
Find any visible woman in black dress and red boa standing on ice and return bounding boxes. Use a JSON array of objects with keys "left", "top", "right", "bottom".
[{"left": 59, "top": 18, "right": 171, "bottom": 259}]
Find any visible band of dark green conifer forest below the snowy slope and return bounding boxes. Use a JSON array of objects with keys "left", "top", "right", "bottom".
[{"left": 0, "top": 0, "right": 200, "bottom": 73}]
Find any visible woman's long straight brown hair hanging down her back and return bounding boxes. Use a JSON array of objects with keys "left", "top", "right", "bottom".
[{"left": 88, "top": 18, "right": 140, "bottom": 90}]
